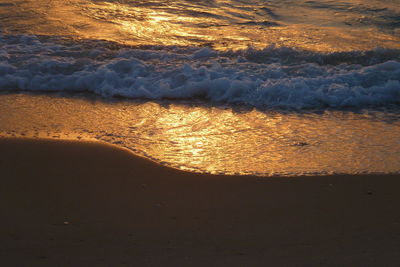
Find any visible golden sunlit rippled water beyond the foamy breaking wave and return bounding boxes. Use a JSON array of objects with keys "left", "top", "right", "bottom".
[{"left": 0, "top": 0, "right": 400, "bottom": 51}]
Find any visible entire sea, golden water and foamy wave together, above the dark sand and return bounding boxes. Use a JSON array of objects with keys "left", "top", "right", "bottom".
[{"left": 0, "top": 0, "right": 400, "bottom": 177}]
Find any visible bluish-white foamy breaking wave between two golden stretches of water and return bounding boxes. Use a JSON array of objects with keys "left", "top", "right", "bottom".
[{"left": 0, "top": 35, "right": 400, "bottom": 109}]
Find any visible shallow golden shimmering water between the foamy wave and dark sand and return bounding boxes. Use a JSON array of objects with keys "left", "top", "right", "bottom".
[{"left": 0, "top": 95, "right": 400, "bottom": 175}]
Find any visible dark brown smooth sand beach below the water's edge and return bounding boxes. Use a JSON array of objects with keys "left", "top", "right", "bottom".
[{"left": 0, "top": 139, "right": 400, "bottom": 266}]
